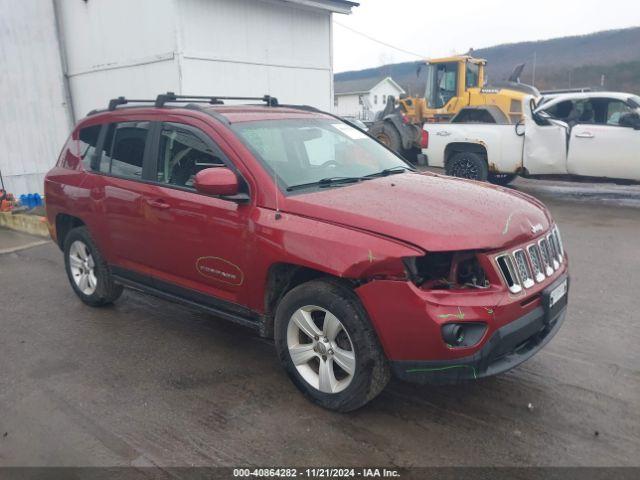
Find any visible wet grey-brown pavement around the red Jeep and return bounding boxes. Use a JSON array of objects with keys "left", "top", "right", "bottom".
[{"left": 0, "top": 199, "right": 640, "bottom": 464}]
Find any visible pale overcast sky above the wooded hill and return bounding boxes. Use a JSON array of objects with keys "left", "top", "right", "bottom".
[{"left": 333, "top": 0, "right": 640, "bottom": 72}]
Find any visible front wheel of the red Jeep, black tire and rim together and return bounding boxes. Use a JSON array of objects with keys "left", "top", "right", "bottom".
[{"left": 274, "top": 279, "right": 390, "bottom": 412}]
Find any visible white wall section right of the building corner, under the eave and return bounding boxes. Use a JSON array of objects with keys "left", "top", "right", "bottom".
[{"left": 176, "top": 0, "right": 333, "bottom": 109}]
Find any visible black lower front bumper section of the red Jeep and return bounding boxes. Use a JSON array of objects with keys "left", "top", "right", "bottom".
[{"left": 390, "top": 276, "right": 568, "bottom": 384}]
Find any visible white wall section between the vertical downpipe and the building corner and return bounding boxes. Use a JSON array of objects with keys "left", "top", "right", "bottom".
[{"left": 57, "top": 0, "right": 179, "bottom": 118}]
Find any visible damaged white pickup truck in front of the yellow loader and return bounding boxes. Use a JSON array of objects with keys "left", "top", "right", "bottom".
[{"left": 422, "top": 92, "right": 640, "bottom": 185}]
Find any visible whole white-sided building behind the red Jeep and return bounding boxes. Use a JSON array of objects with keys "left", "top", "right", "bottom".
[{"left": 0, "top": 0, "right": 357, "bottom": 194}]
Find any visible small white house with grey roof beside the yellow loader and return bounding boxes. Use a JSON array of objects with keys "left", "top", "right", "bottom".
[{"left": 333, "top": 77, "right": 405, "bottom": 120}]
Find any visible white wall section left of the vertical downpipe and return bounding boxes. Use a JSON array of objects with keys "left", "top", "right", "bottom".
[{"left": 0, "top": 0, "right": 70, "bottom": 195}]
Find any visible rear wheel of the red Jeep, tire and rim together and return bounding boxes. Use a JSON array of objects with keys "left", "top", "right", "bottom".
[{"left": 64, "top": 227, "right": 123, "bottom": 307}]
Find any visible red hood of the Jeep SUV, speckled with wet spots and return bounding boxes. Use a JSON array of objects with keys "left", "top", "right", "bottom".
[{"left": 283, "top": 173, "right": 551, "bottom": 251}]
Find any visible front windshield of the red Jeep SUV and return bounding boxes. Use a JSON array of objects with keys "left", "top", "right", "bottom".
[{"left": 231, "top": 118, "right": 413, "bottom": 190}]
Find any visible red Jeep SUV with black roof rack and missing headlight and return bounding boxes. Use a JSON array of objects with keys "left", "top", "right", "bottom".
[{"left": 45, "top": 92, "right": 568, "bottom": 411}]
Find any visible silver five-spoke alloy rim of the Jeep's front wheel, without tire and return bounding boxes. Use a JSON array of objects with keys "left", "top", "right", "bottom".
[{"left": 287, "top": 305, "right": 356, "bottom": 393}]
